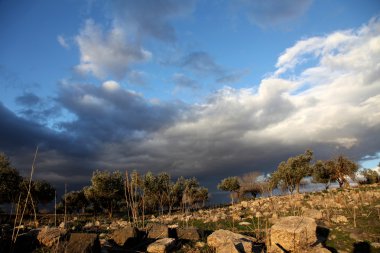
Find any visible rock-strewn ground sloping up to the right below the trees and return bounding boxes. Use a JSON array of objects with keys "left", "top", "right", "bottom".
[{"left": 0, "top": 185, "right": 380, "bottom": 253}]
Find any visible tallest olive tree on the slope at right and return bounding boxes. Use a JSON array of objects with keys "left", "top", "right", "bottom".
[{"left": 273, "top": 150, "right": 313, "bottom": 193}]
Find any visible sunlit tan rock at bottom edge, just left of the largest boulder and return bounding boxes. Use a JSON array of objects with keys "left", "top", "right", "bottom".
[{"left": 207, "top": 229, "right": 256, "bottom": 253}]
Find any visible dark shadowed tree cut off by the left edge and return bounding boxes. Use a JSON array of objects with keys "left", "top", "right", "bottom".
[{"left": 0, "top": 153, "right": 22, "bottom": 204}]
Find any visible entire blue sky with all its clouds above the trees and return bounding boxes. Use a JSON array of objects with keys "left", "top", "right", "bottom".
[{"left": 0, "top": 0, "right": 380, "bottom": 200}]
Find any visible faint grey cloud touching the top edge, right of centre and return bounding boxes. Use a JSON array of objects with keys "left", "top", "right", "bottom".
[{"left": 239, "top": 0, "right": 313, "bottom": 27}]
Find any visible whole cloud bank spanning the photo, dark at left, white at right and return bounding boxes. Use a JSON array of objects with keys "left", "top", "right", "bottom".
[{"left": 0, "top": 19, "right": 380, "bottom": 200}]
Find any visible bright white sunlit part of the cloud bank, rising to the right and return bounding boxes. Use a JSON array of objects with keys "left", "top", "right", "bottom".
[{"left": 130, "top": 17, "right": 380, "bottom": 174}]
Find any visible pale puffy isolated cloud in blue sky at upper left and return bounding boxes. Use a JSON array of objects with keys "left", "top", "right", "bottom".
[{"left": 76, "top": 20, "right": 152, "bottom": 79}]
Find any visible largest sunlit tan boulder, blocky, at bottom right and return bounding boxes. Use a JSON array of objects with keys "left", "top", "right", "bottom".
[{"left": 271, "top": 216, "right": 317, "bottom": 252}]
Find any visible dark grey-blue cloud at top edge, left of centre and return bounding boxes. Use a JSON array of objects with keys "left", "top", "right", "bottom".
[{"left": 112, "top": 0, "right": 195, "bottom": 42}]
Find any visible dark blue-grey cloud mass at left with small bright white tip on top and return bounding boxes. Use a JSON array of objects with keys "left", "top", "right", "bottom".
[{"left": 58, "top": 84, "right": 183, "bottom": 142}]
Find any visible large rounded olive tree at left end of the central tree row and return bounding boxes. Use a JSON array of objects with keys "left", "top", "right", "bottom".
[{"left": 84, "top": 170, "right": 124, "bottom": 218}]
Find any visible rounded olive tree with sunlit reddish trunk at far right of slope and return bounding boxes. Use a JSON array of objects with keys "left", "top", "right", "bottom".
[{"left": 325, "top": 155, "right": 359, "bottom": 188}]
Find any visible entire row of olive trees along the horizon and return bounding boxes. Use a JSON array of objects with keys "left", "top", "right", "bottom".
[{"left": 0, "top": 150, "right": 380, "bottom": 219}]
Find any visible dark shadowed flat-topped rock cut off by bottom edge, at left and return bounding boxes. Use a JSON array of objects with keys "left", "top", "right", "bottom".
[{"left": 65, "top": 233, "right": 100, "bottom": 253}]
